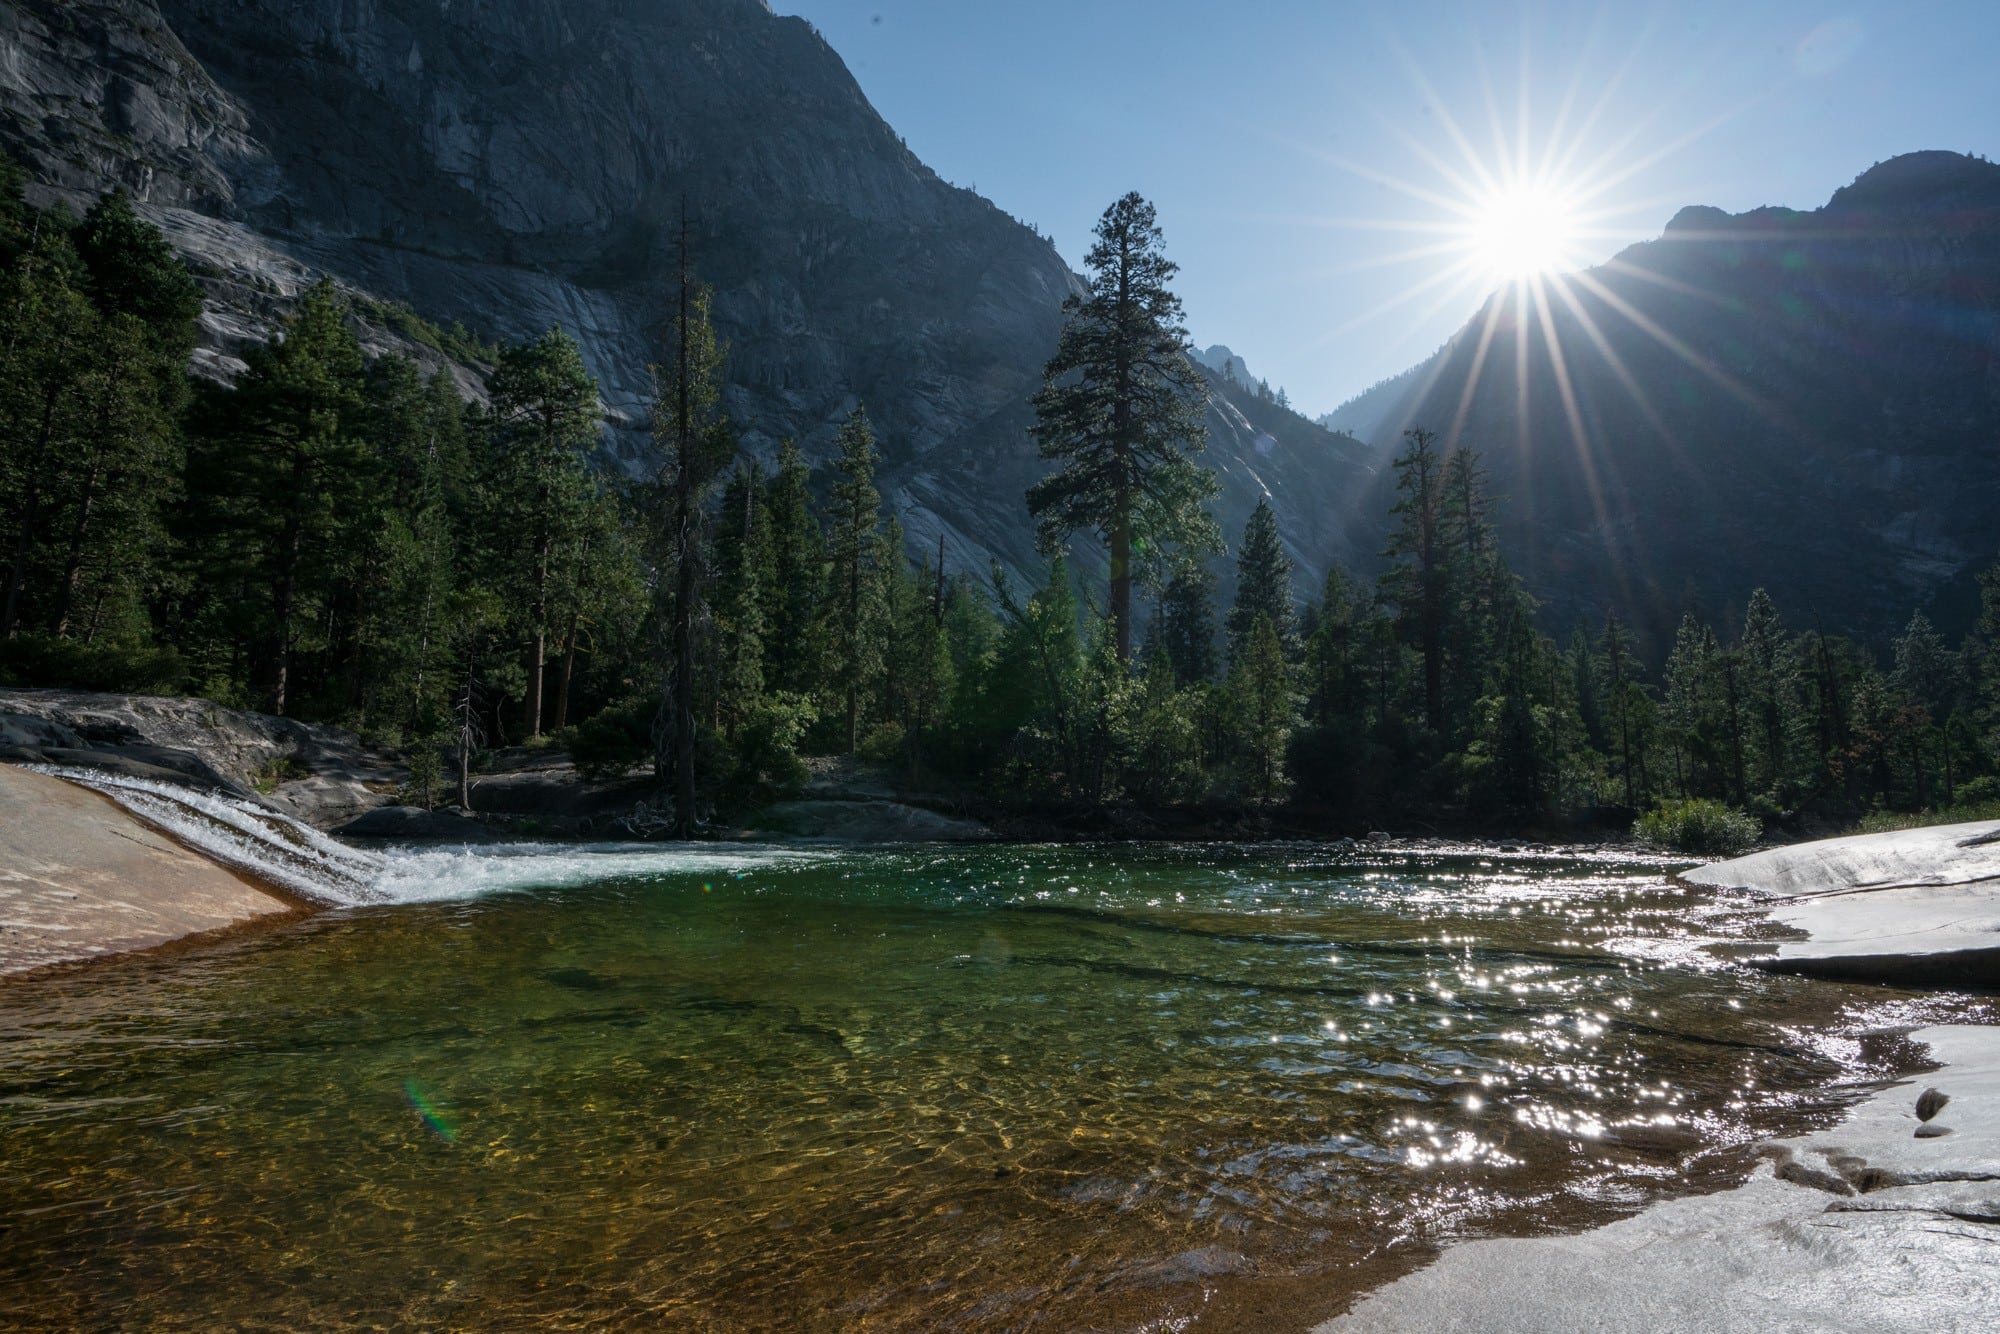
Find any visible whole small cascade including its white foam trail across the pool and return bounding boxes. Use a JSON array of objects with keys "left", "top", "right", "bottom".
[{"left": 24, "top": 764, "right": 834, "bottom": 908}]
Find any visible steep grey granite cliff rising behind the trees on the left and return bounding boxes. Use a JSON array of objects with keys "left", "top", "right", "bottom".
[{"left": 0, "top": 0, "right": 1362, "bottom": 596}]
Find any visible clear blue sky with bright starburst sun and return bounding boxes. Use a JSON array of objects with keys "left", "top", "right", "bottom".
[{"left": 772, "top": 0, "right": 2000, "bottom": 414}]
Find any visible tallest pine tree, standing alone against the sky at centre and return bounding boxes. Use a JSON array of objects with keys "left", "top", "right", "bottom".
[{"left": 1028, "top": 194, "right": 1220, "bottom": 662}]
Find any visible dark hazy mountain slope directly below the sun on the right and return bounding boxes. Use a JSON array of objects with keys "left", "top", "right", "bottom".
[{"left": 1330, "top": 152, "right": 2000, "bottom": 640}]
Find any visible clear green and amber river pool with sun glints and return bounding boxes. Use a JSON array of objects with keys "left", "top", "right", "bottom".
[{"left": 0, "top": 846, "right": 1974, "bottom": 1330}]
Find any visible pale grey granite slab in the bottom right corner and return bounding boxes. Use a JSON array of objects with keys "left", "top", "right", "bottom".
[{"left": 1316, "top": 1026, "right": 2000, "bottom": 1334}]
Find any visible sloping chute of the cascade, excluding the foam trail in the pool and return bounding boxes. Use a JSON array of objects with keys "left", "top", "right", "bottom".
[{"left": 26, "top": 764, "right": 388, "bottom": 908}]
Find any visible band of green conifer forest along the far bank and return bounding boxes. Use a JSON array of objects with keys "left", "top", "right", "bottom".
[{"left": 0, "top": 176, "right": 2000, "bottom": 836}]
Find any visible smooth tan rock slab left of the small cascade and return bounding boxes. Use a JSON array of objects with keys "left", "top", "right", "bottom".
[{"left": 0, "top": 764, "right": 294, "bottom": 974}]
